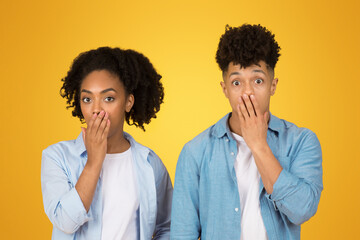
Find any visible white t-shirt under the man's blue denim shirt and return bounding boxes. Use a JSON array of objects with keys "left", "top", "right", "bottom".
[{"left": 232, "top": 133, "right": 268, "bottom": 240}]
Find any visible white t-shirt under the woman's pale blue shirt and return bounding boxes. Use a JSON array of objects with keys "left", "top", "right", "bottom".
[{"left": 101, "top": 148, "right": 140, "bottom": 240}]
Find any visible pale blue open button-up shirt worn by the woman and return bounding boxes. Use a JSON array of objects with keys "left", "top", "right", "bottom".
[{"left": 41, "top": 133, "right": 173, "bottom": 240}]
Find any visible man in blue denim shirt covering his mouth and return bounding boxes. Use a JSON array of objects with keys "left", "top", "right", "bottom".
[{"left": 171, "top": 24, "right": 323, "bottom": 240}]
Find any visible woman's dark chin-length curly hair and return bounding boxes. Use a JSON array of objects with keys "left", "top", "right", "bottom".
[{"left": 60, "top": 47, "right": 164, "bottom": 131}]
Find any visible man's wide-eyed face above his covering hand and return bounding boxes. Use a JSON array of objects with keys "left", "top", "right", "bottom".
[{"left": 220, "top": 61, "right": 278, "bottom": 117}]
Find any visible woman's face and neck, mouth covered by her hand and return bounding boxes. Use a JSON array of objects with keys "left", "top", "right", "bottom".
[{"left": 80, "top": 70, "right": 134, "bottom": 138}]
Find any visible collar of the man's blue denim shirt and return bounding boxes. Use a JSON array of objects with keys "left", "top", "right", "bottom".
[{"left": 213, "top": 112, "right": 281, "bottom": 138}]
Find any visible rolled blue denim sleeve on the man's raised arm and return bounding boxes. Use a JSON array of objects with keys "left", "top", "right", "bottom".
[{"left": 266, "top": 131, "right": 323, "bottom": 225}]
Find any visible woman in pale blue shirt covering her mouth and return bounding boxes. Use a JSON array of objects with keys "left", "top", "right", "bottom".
[{"left": 41, "top": 47, "right": 172, "bottom": 240}]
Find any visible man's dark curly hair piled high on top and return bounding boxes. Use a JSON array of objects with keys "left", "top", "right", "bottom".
[{"left": 216, "top": 24, "right": 280, "bottom": 72}]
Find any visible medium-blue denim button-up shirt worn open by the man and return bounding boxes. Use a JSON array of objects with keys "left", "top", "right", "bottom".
[{"left": 171, "top": 114, "right": 323, "bottom": 240}]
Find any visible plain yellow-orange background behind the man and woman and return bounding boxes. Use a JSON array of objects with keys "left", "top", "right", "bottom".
[{"left": 0, "top": 0, "right": 360, "bottom": 239}]
